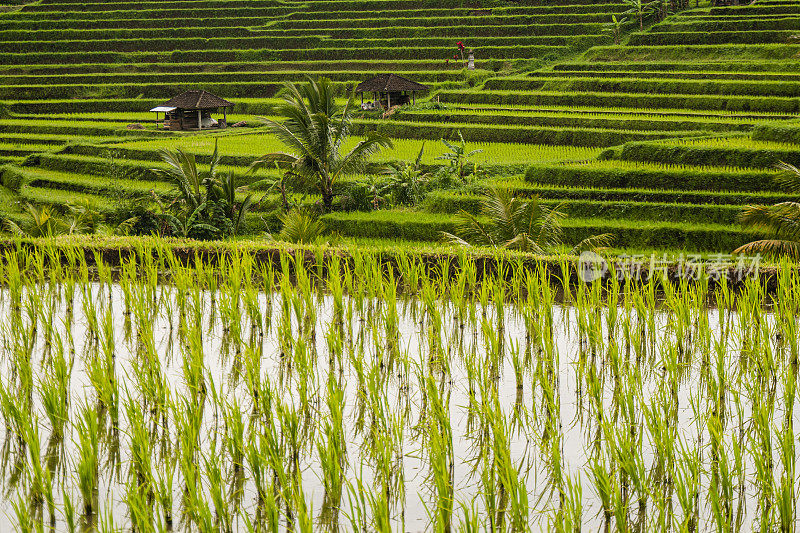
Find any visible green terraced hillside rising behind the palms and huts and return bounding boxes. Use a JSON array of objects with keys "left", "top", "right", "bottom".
[{"left": 0, "top": 0, "right": 800, "bottom": 252}]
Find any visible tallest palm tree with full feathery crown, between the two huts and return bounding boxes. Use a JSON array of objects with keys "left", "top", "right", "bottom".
[{"left": 250, "top": 78, "right": 392, "bottom": 211}]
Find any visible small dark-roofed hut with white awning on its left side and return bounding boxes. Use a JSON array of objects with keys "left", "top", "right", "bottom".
[{"left": 150, "top": 91, "right": 233, "bottom": 130}]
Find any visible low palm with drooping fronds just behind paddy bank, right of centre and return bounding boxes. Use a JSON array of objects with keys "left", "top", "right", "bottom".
[{"left": 443, "top": 187, "right": 613, "bottom": 254}]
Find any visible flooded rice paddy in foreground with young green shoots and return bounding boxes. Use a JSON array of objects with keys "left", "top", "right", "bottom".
[{"left": 0, "top": 249, "right": 800, "bottom": 532}]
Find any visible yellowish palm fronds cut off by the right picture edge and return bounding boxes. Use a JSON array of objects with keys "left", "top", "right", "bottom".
[{"left": 733, "top": 161, "right": 800, "bottom": 259}]
